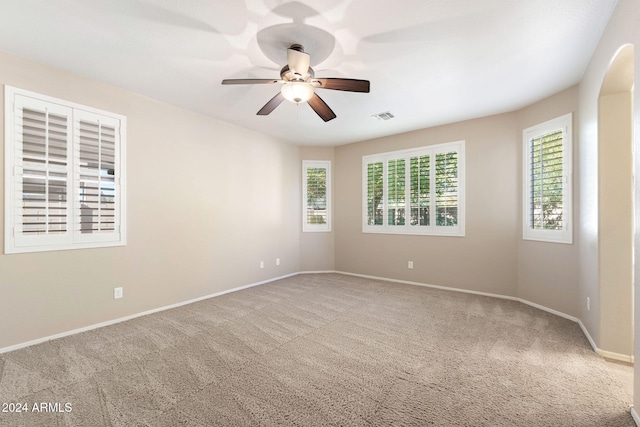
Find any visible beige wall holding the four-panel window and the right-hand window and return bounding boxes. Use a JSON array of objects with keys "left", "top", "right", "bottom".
[{"left": 335, "top": 86, "right": 579, "bottom": 316}]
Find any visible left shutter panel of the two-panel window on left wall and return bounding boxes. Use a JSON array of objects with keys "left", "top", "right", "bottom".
[{"left": 7, "top": 96, "right": 72, "bottom": 247}]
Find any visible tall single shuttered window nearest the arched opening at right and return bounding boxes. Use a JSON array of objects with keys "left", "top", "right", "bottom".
[{"left": 522, "top": 114, "right": 573, "bottom": 243}]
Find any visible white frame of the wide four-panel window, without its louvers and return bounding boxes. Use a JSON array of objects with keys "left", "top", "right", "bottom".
[{"left": 362, "top": 140, "right": 465, "bottom": 237}]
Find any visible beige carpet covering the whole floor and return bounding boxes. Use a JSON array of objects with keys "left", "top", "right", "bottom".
[{"left": 0, "top": 274, "right": 634, "bottom": 427}]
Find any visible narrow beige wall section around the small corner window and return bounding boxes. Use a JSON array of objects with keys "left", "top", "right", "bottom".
[{"left": 300, "top": 147, "right": 336, "bottom": 271}]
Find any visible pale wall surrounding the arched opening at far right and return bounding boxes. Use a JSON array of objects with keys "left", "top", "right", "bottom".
[{"left": 579, "top": 0, "right": 640, "bottom": 408}]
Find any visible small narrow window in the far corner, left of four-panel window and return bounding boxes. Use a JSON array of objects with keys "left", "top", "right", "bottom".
[{"left": 302, "top": 160, "right": 331, "bottom": 231}]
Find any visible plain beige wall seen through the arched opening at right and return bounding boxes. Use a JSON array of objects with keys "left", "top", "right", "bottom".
[{"left": 598, "top": 92, "right": 633, "bottom": 356}]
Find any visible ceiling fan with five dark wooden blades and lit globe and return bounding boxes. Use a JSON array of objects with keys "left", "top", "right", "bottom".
[{"left": 222, "top": 44, "right": 369, "bottom": 122}]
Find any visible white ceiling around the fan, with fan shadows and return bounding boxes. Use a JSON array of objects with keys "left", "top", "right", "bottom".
[{"left": 0, "top": 0, "right": 616, "bottom": 145}]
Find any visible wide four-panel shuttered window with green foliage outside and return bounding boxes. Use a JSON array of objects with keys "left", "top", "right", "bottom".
[{"left": 362, "top": 141, "right": 464, "bottom": 236}]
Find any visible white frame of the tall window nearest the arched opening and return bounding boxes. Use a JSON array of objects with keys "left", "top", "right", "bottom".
[{"left": 522, "top": 113, "right": 573, "bottom": 244}]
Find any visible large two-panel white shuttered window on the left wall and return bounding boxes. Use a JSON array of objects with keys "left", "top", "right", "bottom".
[{"left": 5, "top": 86, "right": 126, "bottom": 253}]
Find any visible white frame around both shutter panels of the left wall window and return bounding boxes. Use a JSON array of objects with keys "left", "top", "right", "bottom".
[{"left": 4, "top": 85, "right": 127, "bottom": 254}]
